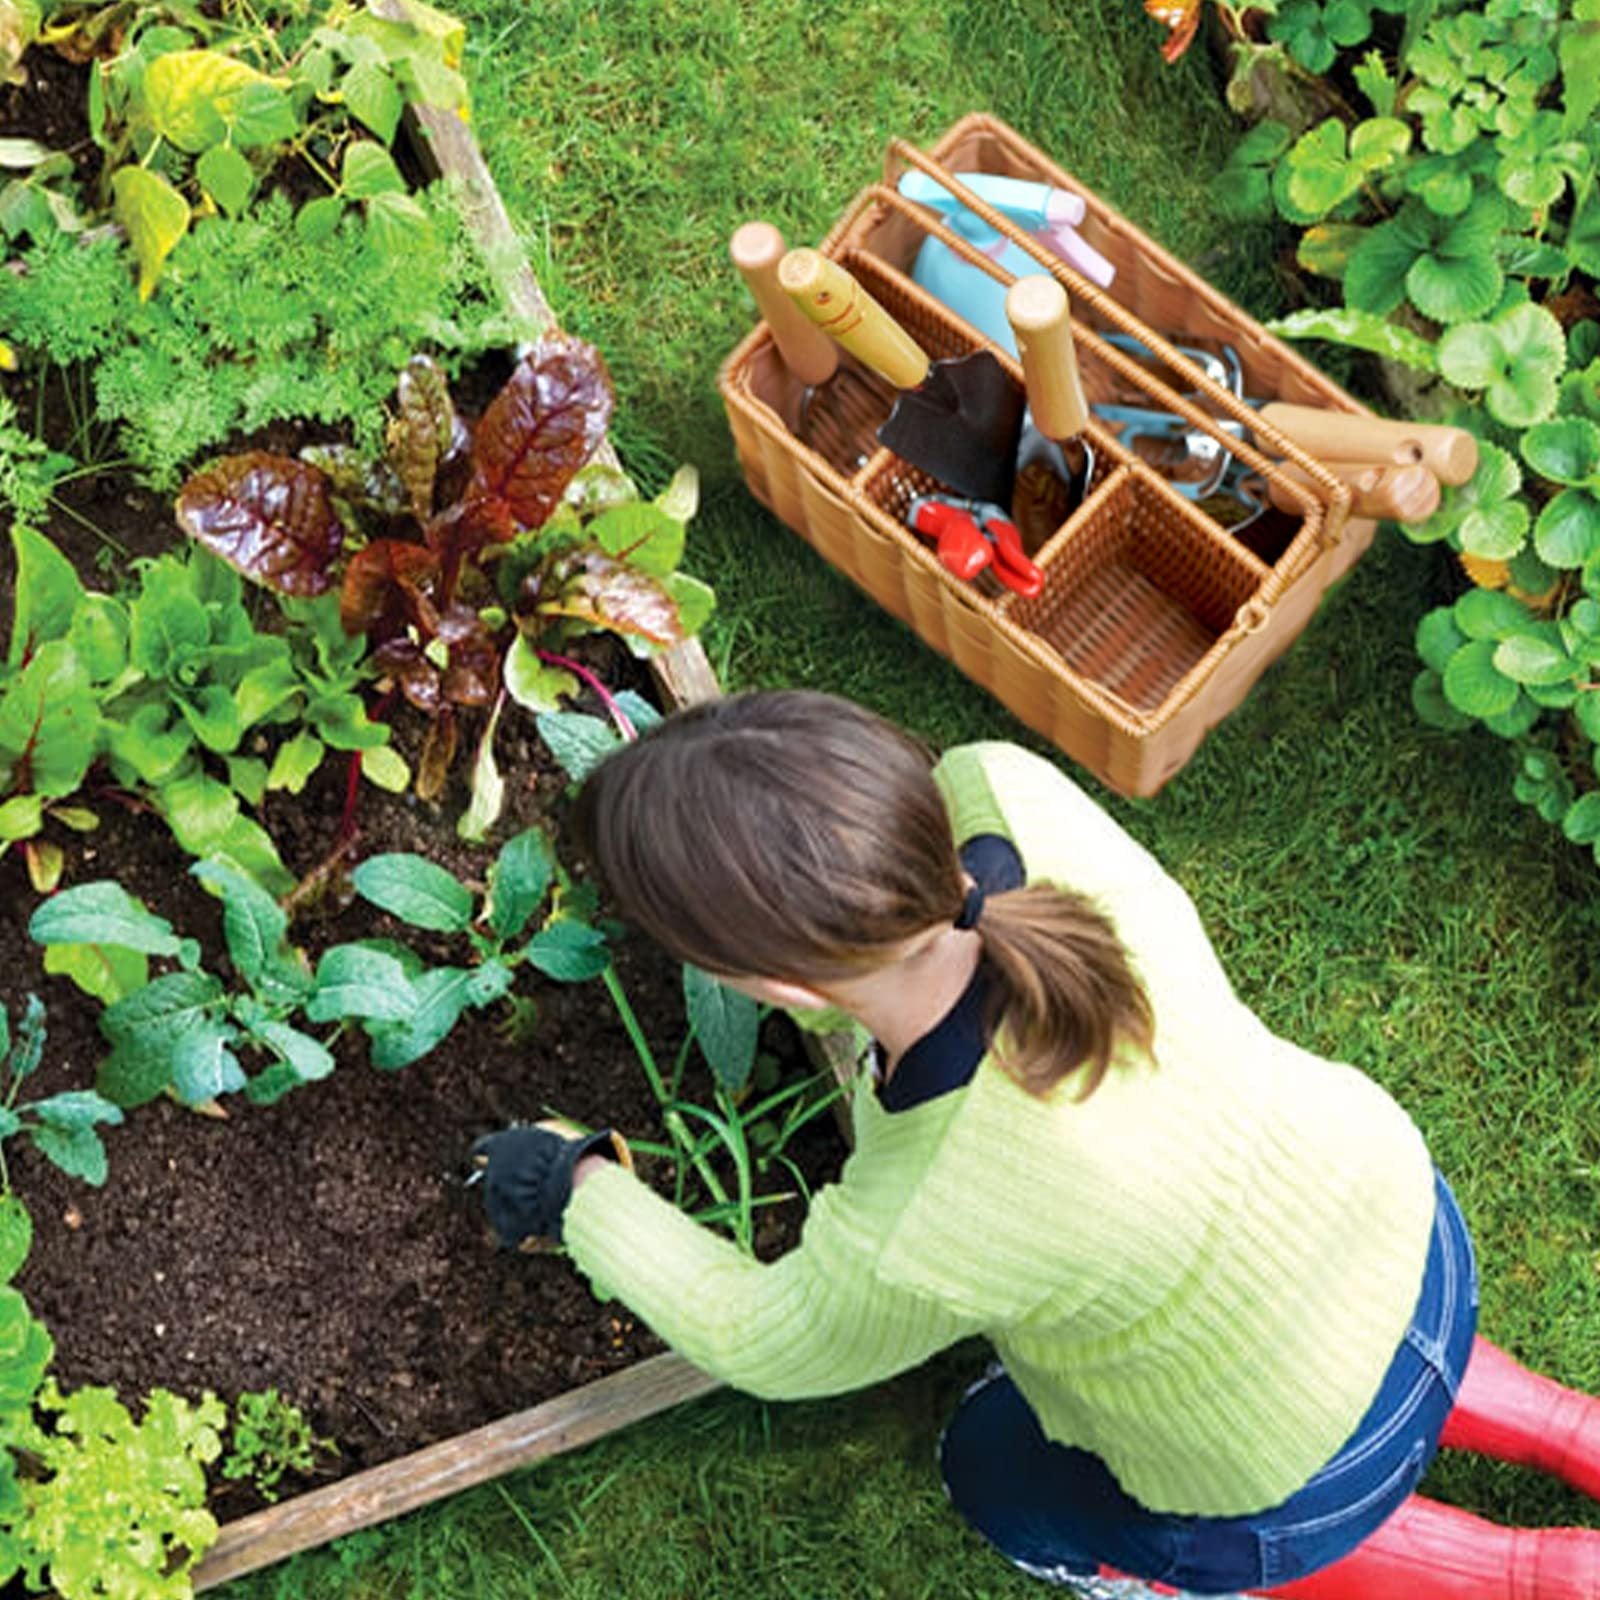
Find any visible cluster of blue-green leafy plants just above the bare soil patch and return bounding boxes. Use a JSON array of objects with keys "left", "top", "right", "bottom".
[{"left": 29, "top": 812, "right": 608, "bottom": 1107}]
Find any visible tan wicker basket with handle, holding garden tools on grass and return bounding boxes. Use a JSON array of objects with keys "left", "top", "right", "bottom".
[{"left": 718, "top": 117, "right": 1376, "bottom": 795}]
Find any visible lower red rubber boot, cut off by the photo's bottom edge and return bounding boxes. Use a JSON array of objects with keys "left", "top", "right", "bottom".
[{"left": 1258, "top": 1494, "right": 1600, "bottom": 1600}]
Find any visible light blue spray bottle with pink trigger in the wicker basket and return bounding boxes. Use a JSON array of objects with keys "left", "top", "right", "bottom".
[{"left": 899, "top": 168, "right": 1117, "bottom": 355}]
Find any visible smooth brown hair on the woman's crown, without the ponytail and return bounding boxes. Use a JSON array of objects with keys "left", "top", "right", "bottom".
[{"left": 578, "top": 690, "right": 965, "bottom": 986}]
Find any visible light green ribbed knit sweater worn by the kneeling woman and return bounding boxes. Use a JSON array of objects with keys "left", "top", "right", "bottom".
[{"left": 565, "top": 744, "right": 1434, "bottom": 1515}]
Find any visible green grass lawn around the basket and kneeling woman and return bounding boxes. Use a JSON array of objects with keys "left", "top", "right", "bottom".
[{"left": 226, "top": 0, "right": 1600, "bottom": 1600}]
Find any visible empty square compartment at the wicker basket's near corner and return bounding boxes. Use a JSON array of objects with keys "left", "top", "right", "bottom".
[{"left": 1010, "top": 470, "right": 1266, "bottom": 714}]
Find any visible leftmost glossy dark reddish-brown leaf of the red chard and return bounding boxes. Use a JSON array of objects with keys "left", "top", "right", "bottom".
[{"left": 176, "top": 450, "right": 344, "bottom": 595}]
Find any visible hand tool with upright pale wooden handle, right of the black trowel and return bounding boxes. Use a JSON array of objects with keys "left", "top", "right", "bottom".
[{"left": 1005, "top": 274, "right": 1094, "bottom": 550}]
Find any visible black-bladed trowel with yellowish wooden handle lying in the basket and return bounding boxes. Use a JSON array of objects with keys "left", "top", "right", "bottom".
[{"left": 778, "top": 250, "right": 1024, "bottom": 506}]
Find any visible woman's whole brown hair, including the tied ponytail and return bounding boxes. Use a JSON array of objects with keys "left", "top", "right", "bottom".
[{"left": 576, "top": 690, "right": 1154, "bottom": 1094}]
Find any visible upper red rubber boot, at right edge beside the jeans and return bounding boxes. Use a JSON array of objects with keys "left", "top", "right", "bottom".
[{"left": 1440, "top": 1338, "right": 1600, "bottom": 1499}]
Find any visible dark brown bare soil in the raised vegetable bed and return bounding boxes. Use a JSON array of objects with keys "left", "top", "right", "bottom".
[{"left": 0, "top": 633, "right": 843, "bottom": 1515}]
